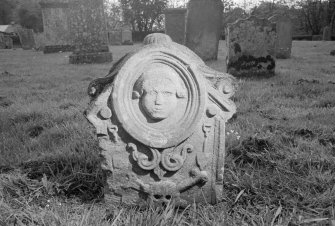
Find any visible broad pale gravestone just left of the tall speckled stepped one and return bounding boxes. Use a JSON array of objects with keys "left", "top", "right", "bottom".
[{"left": 40, "top": 0, "right": 73, "bottom": 53}]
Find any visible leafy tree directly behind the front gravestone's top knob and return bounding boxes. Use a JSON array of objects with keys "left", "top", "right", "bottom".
[{"left": 121, "top": 0, "right": 168, "bottom": 32}]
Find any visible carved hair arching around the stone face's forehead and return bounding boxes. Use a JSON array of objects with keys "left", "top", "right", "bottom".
[{"left": 133, "top": 64, "right": 186, "bottom": 99}]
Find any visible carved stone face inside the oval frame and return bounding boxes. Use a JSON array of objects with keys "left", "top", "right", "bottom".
[{"left": 134, "top": 66, "right": 185, "bottom": 121}]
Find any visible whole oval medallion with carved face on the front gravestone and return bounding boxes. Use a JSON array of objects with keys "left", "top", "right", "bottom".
[{"left": 112, "top": 45, "right": 207, "bottom": 148}]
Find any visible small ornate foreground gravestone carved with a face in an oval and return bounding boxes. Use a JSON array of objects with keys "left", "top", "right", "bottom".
[{"left": 85, "top": 34, "right": 235, "bottom": 206}]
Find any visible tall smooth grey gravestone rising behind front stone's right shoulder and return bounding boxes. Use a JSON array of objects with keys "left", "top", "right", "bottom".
[{"left": 185, "top": 0, "right": 223, "bottom": 61}]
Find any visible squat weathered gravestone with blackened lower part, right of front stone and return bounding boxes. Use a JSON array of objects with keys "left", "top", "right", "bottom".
[{"left": 226, "top": 16, "right": 276, "bottom": 77}]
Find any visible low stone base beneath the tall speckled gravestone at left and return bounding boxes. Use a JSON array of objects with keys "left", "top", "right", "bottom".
[{"left": 69, "top": 52, "right": 113, "bottom": 64}]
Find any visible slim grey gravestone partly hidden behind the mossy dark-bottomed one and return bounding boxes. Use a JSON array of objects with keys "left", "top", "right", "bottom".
[{"left": 269, "top": 14, "right": 293, "bottom": 59}]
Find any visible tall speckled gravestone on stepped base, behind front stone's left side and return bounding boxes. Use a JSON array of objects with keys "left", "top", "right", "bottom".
[{"left": 70, "top": 0, "right": 112, "bottom": 64}]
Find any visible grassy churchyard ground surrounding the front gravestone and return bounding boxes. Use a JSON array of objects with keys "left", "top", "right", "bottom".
[{"left": 0, "top": 41, "right": 335, "bottom": 226}]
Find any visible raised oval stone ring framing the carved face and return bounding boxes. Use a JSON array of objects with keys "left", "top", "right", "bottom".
[{"left": 112, "top": 45, "right": 207, "bottom": 148}]
